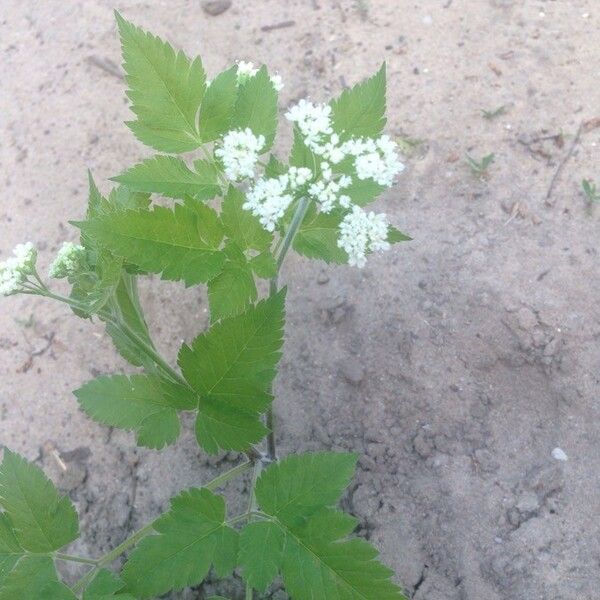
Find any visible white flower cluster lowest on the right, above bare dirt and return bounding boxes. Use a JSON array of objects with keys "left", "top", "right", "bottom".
[{"left": 338, "top": 206, "right": 390, "bottom": 268}]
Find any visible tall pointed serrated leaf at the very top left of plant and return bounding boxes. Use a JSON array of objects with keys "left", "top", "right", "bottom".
[{"left": 116, "top": 13, "right": 206, "bottom": 152}]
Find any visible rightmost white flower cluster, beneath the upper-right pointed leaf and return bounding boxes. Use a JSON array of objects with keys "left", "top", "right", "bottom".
[{"left": 344, "top": 135, "right": 404, "bottom": 187}]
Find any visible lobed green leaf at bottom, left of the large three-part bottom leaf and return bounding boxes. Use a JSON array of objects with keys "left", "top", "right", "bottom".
[{"left": 122, "top": 488, "right": 238, "bottom": 598}]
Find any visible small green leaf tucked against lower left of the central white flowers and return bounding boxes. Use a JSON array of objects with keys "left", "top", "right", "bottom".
[{"left": 221, "top": 186, "right": 273, "bottom": 251}]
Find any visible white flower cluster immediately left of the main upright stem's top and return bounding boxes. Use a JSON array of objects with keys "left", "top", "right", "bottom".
[{"left": 243, "top": 167, "right": 312, "bottom": 231}]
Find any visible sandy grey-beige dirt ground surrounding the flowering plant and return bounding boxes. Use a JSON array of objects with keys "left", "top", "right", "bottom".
[{"left": 0, "top": 0, "right": 600, "bottom": 600}]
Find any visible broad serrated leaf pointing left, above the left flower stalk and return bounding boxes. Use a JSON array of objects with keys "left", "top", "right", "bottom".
[{"left": 77, "top": 203, "right": 225, "bottom": 286}]
